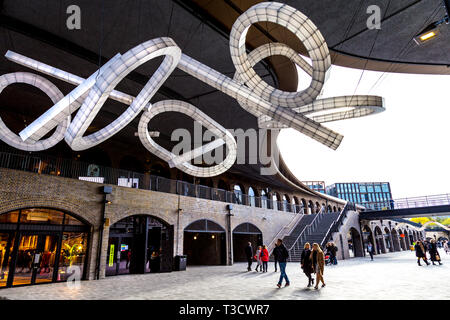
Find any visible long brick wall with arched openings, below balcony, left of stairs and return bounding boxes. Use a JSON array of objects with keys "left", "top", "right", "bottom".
[{"left": 0, "top": 168, "right": 295, "bottom": 279}]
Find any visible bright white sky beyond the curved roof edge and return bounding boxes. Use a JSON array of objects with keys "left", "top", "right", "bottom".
[{"left": 278, "top": 65, "right": 450, "bottom": 199}]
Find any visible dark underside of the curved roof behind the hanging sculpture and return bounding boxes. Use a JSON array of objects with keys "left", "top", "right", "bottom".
[{"left": 0, "top": 0, "right": 450, "bottom": 192}]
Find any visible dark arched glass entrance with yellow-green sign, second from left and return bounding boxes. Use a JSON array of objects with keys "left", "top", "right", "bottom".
[{"left": 106, "top": 215, "right": 173, "bottom": 276}]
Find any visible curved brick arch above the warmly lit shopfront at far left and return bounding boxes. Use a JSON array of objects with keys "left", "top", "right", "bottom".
[{"left": 0, "top": 198, "right": 96, "bottom": 226}]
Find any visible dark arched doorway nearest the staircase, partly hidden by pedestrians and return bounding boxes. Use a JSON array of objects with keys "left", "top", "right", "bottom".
[{"left": 233, "top": 223, "right": 263, "bottom": 262}]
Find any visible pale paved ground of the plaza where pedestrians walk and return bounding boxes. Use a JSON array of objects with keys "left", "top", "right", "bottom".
[{"left": 0, "top": 252, "right": 450, "bottom": 300}]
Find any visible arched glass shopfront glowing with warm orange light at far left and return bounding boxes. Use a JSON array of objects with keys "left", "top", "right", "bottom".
[{"left": 0, "top": 208, "right": 90, "bottom": 288}]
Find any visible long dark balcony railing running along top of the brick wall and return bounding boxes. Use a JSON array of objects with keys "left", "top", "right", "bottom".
[{"left": 0, "top": 152, "right": 303, "bottom": 214}]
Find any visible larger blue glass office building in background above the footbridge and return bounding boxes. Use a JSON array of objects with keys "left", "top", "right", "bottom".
[{"left": 326, "top": 182, "right": 393, "bottom": 210}]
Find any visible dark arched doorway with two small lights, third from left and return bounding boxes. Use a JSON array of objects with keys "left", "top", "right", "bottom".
[{"left": 183, "top": 219, "right": 226, "bottom": 265}]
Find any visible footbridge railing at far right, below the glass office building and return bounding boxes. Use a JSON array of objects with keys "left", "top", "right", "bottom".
[{"left": 362, "top": 193, "right": 450, "bottom": 211}]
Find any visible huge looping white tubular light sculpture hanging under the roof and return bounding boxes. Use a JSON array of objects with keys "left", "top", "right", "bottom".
[{"left": 0, "top": 2, "right": 384, "bottom": 177}]
